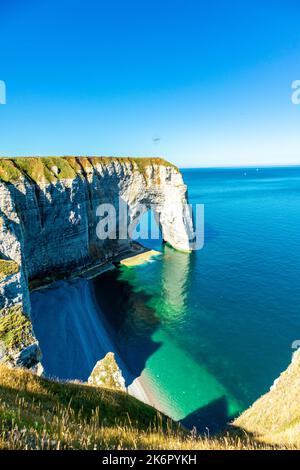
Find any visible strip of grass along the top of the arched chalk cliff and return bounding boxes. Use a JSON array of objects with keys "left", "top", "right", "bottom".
[{"left": 0, "top": 157, "right": 177, "bottom": 183}]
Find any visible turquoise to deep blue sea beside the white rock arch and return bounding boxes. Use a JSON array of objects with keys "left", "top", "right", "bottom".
[{"left": 32, "top": 168, "right": 300, "bottom": 432}]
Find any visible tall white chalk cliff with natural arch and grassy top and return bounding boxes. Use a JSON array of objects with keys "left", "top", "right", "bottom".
[{"left": 0, "top": 157, "right": 192, "bottom": 368}]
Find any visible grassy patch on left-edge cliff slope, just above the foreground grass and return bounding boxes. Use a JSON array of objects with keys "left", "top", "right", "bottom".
[{"left": 0, "top": 305, "right": 35, "bottom": 360}]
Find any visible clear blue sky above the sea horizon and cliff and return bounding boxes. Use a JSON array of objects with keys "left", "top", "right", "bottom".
[{"left": 0, "top": 0, "right": 300, "bottom": 167}]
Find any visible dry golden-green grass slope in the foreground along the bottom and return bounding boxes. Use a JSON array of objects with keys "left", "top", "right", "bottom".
[{"left": 0, "top": 364, "right": 296, "bottom": 450}]
